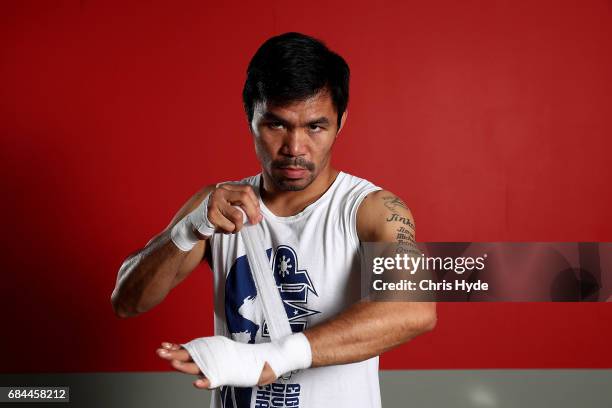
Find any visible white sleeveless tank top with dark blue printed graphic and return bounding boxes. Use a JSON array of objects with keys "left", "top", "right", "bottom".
[{"left": 210, "top": 172, "right": 381, "bottom": 408}]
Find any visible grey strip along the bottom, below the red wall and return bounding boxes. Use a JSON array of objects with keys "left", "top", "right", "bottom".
[{"left": 0, "top": 370, "right": 612, "bottom": 408}]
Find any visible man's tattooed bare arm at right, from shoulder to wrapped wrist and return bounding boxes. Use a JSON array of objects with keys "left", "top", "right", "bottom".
[{"left": 304, "top": 190, "right": 436, "bottom": 367}]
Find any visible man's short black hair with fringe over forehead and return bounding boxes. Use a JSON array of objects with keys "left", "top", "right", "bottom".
[{"left": 242, "top": 32, "right": 350, "bottom": 128}]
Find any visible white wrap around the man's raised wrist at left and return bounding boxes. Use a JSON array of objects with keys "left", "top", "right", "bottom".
[{"left": 170, "top": 194, "right": 215, "bottom": 252}]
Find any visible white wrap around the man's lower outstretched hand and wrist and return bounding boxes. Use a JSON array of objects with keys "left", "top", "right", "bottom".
[{"left": 181, "top": 332, "right": 312, "bottom": 388}]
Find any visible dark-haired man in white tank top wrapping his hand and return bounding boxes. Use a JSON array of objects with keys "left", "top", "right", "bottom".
[{"left": 112, "top": 33, "right": 436, "bottom": 407}]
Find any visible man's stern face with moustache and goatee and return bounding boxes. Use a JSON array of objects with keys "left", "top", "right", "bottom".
[{"left": 251, "top": 88, "right": 346, "bottom": 191}]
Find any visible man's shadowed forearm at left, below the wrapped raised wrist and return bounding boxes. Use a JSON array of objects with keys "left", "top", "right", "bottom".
[{"left": 111, "top": 231, "right": 187, "bottom": 317}]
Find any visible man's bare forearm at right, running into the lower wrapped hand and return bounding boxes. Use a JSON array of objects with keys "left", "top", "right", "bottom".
[{"left": 304, "top": 302, "right": 436, "bottom": 367}]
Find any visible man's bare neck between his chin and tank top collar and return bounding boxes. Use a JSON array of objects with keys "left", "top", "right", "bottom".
[{"left": 260, "top": 166, "right": 339, "bottom": 217}]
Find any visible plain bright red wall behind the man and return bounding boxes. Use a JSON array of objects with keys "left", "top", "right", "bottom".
[{"left": 0, "top": 0, "right": 612, "bottom": 372}]
